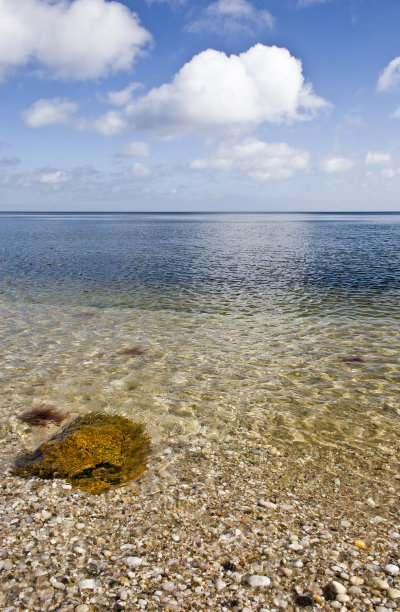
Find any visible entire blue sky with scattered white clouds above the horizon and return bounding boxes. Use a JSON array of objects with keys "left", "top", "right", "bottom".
[{"left": 0, "top": 0, "right": 400, "bottom": 211}]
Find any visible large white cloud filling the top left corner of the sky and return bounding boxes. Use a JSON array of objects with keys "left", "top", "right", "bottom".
[{"left": 0, "top": 0, "right": 151, "bottom": 80}]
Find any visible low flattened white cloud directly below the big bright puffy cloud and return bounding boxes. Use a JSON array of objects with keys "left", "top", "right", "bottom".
[{"left": 190, "top": 138, "right": 310, "bottom": 181}]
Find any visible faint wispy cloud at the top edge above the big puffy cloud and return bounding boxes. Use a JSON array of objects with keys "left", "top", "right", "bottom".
[{"left": 186, "top": 0, "right": 274, "bottom": 32}]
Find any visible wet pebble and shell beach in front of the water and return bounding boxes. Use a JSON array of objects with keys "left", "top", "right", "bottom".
[{"left": 0, "top": 430, "right": 400, "bottom": 612}]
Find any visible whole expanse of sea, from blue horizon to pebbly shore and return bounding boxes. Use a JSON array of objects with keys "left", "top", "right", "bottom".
[{"left": 0, "top": 214, "right": 400, "bottom": 476}]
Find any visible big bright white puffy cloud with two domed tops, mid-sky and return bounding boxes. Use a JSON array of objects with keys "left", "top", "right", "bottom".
[{"left": 126, "top": 44, "right": 329, "bottom": 136}]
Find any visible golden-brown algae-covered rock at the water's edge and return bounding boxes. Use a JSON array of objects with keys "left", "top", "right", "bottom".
[{"left": 13, "top": 413, "right": 150, "bottom": 493}]
